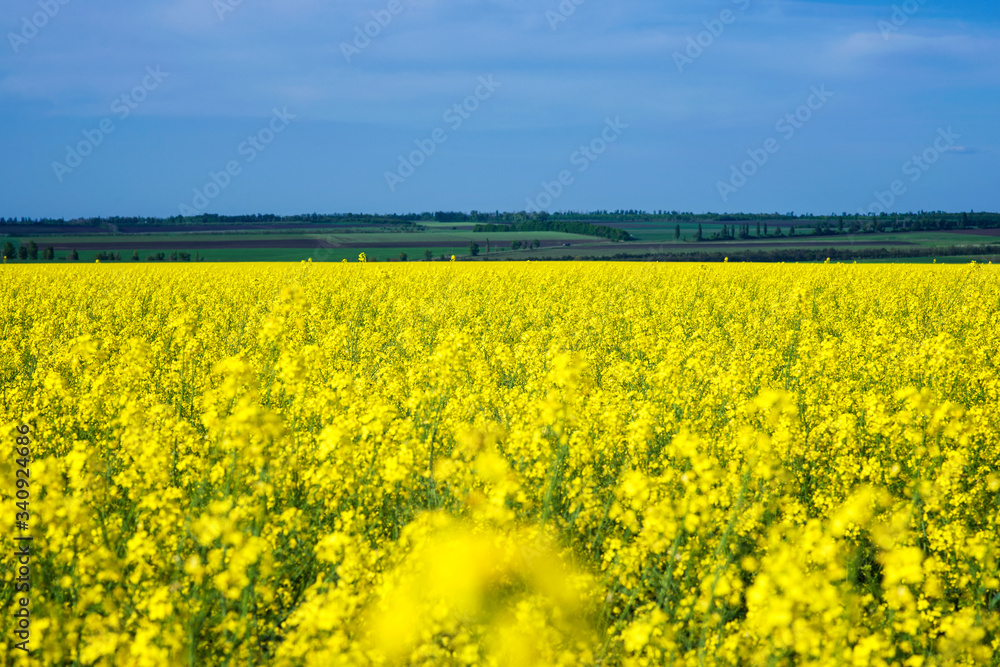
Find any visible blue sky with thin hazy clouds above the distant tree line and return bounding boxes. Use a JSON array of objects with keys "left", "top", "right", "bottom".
[{"left": 0, "top": 0, "right": 1000, "bottom": 218}]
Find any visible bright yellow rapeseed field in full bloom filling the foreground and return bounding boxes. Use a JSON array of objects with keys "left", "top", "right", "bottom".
[{"left": 0, "top": 262, "right": 1000, "bottom": 667}]
